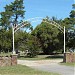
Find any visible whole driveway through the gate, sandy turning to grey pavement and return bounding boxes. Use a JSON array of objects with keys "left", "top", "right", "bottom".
[{"left": 18, "top": 60, "right": 75, "bottom": 75}]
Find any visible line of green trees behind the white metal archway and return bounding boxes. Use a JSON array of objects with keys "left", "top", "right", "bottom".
[{"left": 0, "top": 0, "right": 75, "bottom": 57}]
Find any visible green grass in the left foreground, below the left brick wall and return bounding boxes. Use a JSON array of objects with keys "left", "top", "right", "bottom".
[{"left": 0, "top": 65, "right": 59, "bottom": 75}]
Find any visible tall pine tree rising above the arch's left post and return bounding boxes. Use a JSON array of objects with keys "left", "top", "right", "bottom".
[{"left": 0, "top": 0, "right": 25, "bottom": 27}]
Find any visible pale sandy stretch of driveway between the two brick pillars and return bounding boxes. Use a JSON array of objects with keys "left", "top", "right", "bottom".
[{"left": 18, "top": 59, "right": 63, "bottom": 66}]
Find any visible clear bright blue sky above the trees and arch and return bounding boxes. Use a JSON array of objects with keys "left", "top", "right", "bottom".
[{"left": 0, "top": 0, "right": 75, "bottom": 27}]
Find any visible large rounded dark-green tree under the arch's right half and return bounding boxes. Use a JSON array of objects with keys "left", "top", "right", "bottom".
[{"left": 32, "top": 19, "right": 59, "bottom": 54}]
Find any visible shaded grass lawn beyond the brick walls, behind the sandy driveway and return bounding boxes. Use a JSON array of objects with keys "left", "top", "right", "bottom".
[{"left": 0, "top": 52, "right": 63, "bottom": 60}]
